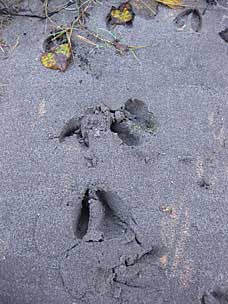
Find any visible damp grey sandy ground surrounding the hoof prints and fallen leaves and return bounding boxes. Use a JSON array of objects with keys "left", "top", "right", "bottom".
[{"left": 0, "top": 1, "right": 228, "bottom": 304}]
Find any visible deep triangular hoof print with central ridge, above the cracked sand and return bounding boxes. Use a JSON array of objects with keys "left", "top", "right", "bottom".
[{"left": 74, "top": 187, "right": 127, "bottom": 242}]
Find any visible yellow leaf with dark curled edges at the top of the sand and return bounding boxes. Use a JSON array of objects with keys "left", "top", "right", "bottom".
[{"left": 106, "top": 2, "right": 135, "bottom": 26}]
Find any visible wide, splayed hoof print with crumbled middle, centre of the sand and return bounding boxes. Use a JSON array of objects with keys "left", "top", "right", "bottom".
[{"left": 59, "top": 99, "right": 158, "bottom": 148}]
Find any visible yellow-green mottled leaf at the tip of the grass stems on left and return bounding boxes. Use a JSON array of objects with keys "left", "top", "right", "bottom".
[{"left": 40, "top": 43, "right": 71, "bottom": 72}]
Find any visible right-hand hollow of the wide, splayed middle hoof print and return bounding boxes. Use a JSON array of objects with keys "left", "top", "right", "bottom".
[{"left": 110, "top": 99, "right": 157, "bottom": 146}]
